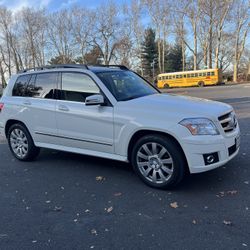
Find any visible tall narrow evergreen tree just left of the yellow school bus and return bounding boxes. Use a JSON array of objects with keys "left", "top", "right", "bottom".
[{"left": 142, "top": 28, "right": 158, "bottom": 80}]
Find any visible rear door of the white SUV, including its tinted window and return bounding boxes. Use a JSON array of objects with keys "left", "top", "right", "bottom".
[{"left": 13, "top": 72, "right": 58, "bottom": 146}]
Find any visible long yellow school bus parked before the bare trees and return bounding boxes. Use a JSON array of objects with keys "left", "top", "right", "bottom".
[{"left": 157, "top": 69, "right": 222, "bottom": 88}]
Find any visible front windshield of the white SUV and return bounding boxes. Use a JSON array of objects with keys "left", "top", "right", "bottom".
[{"left": 97, "top": 71, "right": 159, "bottom": 101}]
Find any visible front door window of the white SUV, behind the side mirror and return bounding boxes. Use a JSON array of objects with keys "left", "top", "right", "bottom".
[{"left": 61, "top": 73, "right": 100, "bottom": 102}]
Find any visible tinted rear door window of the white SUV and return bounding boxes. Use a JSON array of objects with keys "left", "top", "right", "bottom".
[{"left": 27, "top": 73, "right": 58, "bottom": 99}]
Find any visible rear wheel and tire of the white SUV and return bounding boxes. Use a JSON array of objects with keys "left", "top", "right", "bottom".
[{"left": 7, "top": 123, "right": 40, "bottom": 161}]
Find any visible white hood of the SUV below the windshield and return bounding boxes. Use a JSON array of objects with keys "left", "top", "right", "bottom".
[{"left": 119, "top": 94, "right": 232, "bottom": 118}]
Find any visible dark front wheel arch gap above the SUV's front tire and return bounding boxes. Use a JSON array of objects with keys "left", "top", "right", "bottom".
[{"left": 127, "top": 129, "right": 189, "bottom": 171}]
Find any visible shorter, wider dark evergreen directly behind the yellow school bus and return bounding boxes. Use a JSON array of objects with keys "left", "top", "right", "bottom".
[{"left": 165, "top": 43, "right": 182, "bottom": 72}]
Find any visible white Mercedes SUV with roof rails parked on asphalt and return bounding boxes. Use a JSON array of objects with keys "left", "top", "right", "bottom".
[{"left": 0, "top": 65, "right": 240, "bottom": 188}]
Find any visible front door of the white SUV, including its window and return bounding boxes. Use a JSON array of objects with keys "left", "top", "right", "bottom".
[{"left": 56, "top": 72, "right": 114, "bottom": 153}]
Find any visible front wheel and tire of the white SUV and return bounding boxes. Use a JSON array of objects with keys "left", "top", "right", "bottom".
[{"left": 131, "top": 134, "right": 186, "bottom": 189}]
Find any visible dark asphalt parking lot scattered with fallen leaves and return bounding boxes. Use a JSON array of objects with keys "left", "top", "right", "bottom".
[{"left": 0, "top": 84, "right": 250, "bottom": 250}]
